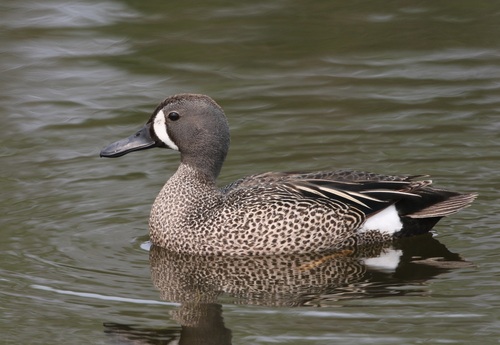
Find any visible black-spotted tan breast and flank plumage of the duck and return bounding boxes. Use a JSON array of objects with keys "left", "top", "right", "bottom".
[{"left": 150, "top": 164, "right": 372, "bottom": 254}]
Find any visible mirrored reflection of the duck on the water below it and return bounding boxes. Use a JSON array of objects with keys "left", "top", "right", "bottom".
[{"left": 105, "top": 235, "right": 470, "bottom": 344}]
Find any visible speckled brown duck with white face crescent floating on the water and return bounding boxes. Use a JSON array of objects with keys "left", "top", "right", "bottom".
[{"left": 100, "top": 93, "right": 477, "bottom": 255}]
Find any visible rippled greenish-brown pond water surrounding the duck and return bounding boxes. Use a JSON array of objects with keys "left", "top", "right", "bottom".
[{"left": 0, "top": 0, "right": 500, "bottom": 344}]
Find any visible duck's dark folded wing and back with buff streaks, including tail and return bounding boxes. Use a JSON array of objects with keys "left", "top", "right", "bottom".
[{"left": 223, "top": 170, "right": 477, "bottom": 236}]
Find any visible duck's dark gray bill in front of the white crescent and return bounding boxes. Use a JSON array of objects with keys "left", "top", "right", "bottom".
[{"left": 100, "top": 123, "right": 157, "bottom": 158}]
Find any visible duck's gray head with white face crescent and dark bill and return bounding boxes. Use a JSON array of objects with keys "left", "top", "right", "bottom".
[{"left": 101, "top": 94, "right": 230, "bottom": 180}]
